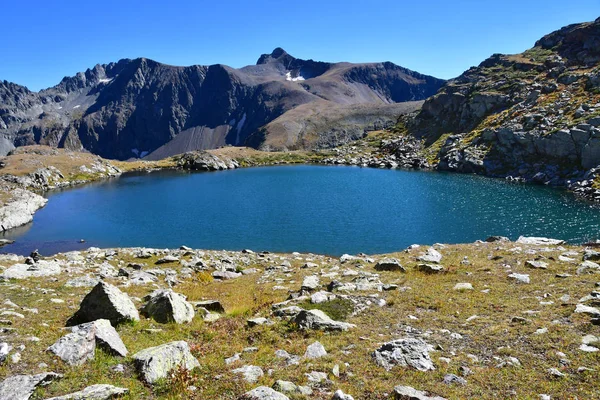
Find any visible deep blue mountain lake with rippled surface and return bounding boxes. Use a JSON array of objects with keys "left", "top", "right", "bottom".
[{"left": 1, "top": 165, "right": 600, "bottom": 255}]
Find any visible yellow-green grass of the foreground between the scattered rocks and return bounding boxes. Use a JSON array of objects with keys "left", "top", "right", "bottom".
[{"left": 0, "top": 243, "right": 600, "bottom": 399}]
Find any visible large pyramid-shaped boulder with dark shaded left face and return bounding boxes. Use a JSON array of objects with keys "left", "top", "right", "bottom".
[{"left": 67, "top": 282, "right": 140, "bottom": 326}]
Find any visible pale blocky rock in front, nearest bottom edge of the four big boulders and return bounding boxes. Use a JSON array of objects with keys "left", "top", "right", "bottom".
[{"left": 132, "top": 341, "right": 200, "bottom": 384}]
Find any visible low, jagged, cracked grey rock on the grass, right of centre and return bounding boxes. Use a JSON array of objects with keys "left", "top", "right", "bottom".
[{"left": 372, "top": 338, "right": 435, "bottom": 371}]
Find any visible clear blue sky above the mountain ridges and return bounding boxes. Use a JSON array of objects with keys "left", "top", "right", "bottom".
[{"left": 0, "top": 0, "right": 600, "bottom": 90}]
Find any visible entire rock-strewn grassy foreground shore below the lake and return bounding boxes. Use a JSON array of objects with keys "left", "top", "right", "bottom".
[{"left": 0, "top": 237, "right": 600, "bottom": 400}]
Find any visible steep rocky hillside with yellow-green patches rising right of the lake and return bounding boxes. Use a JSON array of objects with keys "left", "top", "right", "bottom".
[{"left": 401, "top": 19, "right": 600, "bottom": 195}]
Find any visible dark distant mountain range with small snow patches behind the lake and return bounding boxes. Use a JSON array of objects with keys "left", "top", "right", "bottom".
[{"left": 0, "top": 48, "right": 445, "bottom": 160}]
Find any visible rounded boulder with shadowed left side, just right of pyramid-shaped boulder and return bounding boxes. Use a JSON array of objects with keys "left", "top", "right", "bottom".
[{"left": 142, "top": 289, "right": 195, "bottom": 324}]
